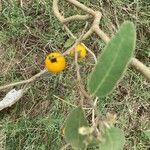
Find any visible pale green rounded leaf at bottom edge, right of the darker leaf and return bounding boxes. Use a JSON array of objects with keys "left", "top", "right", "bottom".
[{"left": 99, "top": 127, "right": 125, "bottom": 150}]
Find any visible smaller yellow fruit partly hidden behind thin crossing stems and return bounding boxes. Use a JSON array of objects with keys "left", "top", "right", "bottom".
[{"left": 71, "top": 43, "right": 87, "bottom": 59}]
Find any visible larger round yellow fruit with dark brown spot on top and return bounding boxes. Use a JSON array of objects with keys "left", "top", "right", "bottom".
[{"left": 45, "top": 52, "right": 66, "bottom": 73}]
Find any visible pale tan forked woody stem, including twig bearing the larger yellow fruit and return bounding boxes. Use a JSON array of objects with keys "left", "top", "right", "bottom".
[{"left": 0, "top": 0, "right": 150, "bottom": 90}]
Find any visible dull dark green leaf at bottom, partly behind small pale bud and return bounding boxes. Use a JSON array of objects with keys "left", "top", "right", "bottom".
[{"left": 64, "top": 107, "right": 88, "bottom": 150}]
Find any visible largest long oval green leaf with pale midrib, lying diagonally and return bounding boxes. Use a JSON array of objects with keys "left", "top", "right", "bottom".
[{"left": 88, "top": 21, "right": 136, "bottom": 97}]
